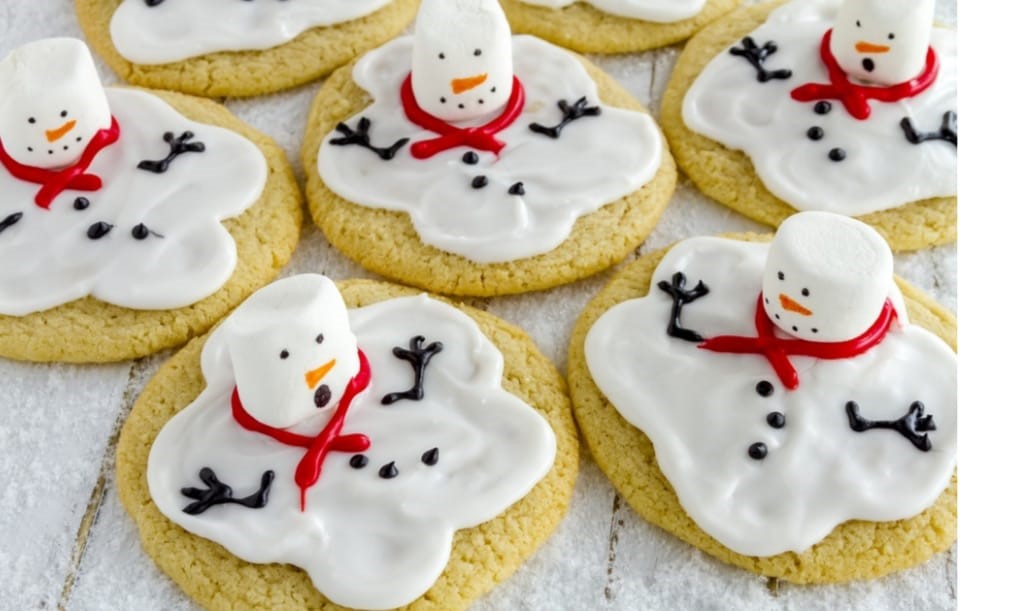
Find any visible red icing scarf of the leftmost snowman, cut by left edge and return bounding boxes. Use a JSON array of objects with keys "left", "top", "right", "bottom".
[{"left": 0, "top": 116, "right": 119, "bottom": 210}]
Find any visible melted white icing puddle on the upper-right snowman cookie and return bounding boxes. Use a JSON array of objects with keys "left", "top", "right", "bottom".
[{"left": 682, "top": 0, "right": 957, "bottom": 216}]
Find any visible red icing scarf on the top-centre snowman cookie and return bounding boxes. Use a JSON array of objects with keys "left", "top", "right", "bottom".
[{"left": 400, "top": 74, "right": 527, "bottom": 159}]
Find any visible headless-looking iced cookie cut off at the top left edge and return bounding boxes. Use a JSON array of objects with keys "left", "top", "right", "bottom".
[{"left": 75, "top": 0, "right": 419, "bottom": 97}]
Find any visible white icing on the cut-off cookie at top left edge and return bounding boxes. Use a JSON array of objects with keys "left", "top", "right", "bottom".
[{"left": 109, "top": 0, "right": 391, "bottom": 64}]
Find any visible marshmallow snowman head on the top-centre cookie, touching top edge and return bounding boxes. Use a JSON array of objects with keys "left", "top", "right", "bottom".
[{"left": 410, "top": 0, "right": 513, "bottom": 121}]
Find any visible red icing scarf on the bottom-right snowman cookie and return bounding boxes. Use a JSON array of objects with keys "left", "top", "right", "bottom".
[{"left": 699, "top": 293, "right": 899, "bottom": 390}]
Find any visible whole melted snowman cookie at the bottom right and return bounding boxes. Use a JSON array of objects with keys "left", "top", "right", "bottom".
[{"left": 569, "top": 211, "right": 956, "bottom": 583}]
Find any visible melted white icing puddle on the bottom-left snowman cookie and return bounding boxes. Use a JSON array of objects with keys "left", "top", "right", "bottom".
[{"left": 148, "top": 280, "right": 555, "bottom": 609}]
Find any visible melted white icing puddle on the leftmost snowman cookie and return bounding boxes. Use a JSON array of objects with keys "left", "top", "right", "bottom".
[{"left": 0, "top": 89, "right": 267, "bottom": 316}]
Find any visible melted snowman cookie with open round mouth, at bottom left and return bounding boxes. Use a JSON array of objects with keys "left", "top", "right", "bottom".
[{"left": 116, "top": 274, "right": 578, "bottom": 609}]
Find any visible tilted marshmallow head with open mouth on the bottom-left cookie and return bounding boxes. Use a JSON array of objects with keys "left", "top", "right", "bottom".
[{"left": 226, "top": 274, "right": 359, "bottom": 428}]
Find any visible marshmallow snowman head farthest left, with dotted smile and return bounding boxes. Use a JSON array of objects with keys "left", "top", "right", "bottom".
[{"left": 0, "top": 38, "right": 112, "bottom": 169}]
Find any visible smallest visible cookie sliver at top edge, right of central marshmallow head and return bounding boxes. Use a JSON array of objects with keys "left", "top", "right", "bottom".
[{"left": 499, "top": 0, "right": 743, "bottom": 54}]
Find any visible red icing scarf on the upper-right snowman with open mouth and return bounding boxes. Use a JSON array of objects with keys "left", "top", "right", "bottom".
[{"left": 790, "top": 28, "right": 940, "bottom": 120}]
